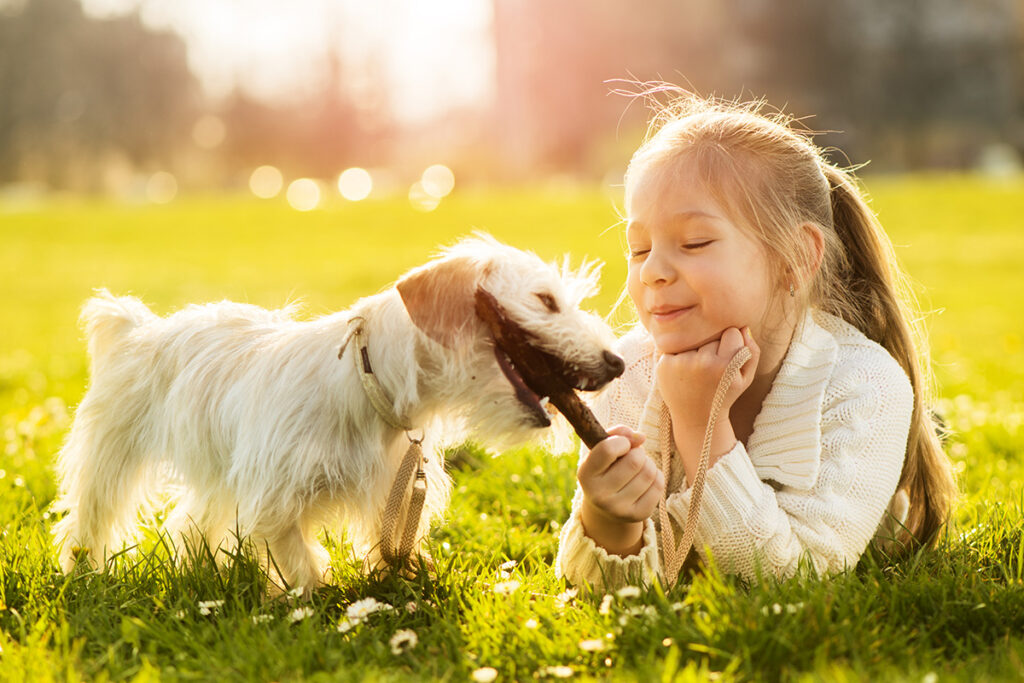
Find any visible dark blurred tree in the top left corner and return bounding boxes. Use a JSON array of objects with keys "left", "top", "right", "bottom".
[{"left": 0, "top": 0, "right": 200, "bottom": 189}]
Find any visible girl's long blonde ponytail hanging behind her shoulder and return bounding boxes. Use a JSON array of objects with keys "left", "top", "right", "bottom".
[{"left": 821, "top": 162, "right": 958, "bottom": 550}]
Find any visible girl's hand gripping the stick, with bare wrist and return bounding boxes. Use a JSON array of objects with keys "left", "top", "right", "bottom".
[{"left": 577, "top": 425, "right": 665, "bottom": 555}]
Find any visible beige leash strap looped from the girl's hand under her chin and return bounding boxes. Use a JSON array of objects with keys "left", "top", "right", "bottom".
[{"left": 657, "top": 346, "right": 753, "bottom": 586}]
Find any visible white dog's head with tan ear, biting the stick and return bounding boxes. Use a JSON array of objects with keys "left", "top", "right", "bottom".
[{"left": 397, "top": 233, "right": 623, "bottom": 433}]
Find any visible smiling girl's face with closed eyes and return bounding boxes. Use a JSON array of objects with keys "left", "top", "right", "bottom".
[{"left": 626, "top": 163, "right": 782, "bottom": 353}]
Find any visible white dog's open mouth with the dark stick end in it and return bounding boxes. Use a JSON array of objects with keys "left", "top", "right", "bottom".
[{"left": 476, "top": 288, "right": 624, "bottom": 438}]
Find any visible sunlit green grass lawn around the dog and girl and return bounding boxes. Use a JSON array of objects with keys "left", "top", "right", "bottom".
[{"left": 0, "top": 177, "right": 1024, "bottom": 681}]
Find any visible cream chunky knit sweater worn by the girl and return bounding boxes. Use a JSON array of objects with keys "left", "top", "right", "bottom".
[{"left": 555, "top": 311, "right": 913, "bottom": 590}]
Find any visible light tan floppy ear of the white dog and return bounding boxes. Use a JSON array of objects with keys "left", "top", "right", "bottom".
[{"left": 395, "top": 256, "right": 486, "bottom": 348}]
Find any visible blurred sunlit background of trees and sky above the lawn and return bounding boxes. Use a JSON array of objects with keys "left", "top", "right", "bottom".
[{"left": 0, "top": 0, "right": 1024, "bottom": 211}]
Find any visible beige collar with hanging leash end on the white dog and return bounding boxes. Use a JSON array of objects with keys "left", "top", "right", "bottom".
[{"left": 338, "top": 317, "right": 427, "bottom": 566}]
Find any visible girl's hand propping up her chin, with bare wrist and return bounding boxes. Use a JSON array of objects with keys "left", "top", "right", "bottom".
[{"left": 655, "top": 328, "right": 761, "bottom": 481}]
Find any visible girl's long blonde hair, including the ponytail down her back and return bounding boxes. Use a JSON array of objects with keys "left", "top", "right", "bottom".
[{"left": 626, "top": 86, "right": 958, "bottom": 550}]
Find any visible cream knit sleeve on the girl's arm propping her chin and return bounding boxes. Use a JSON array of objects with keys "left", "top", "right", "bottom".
[{"left": 669, "top": 354, "right": 913, "bottom": 580}]
